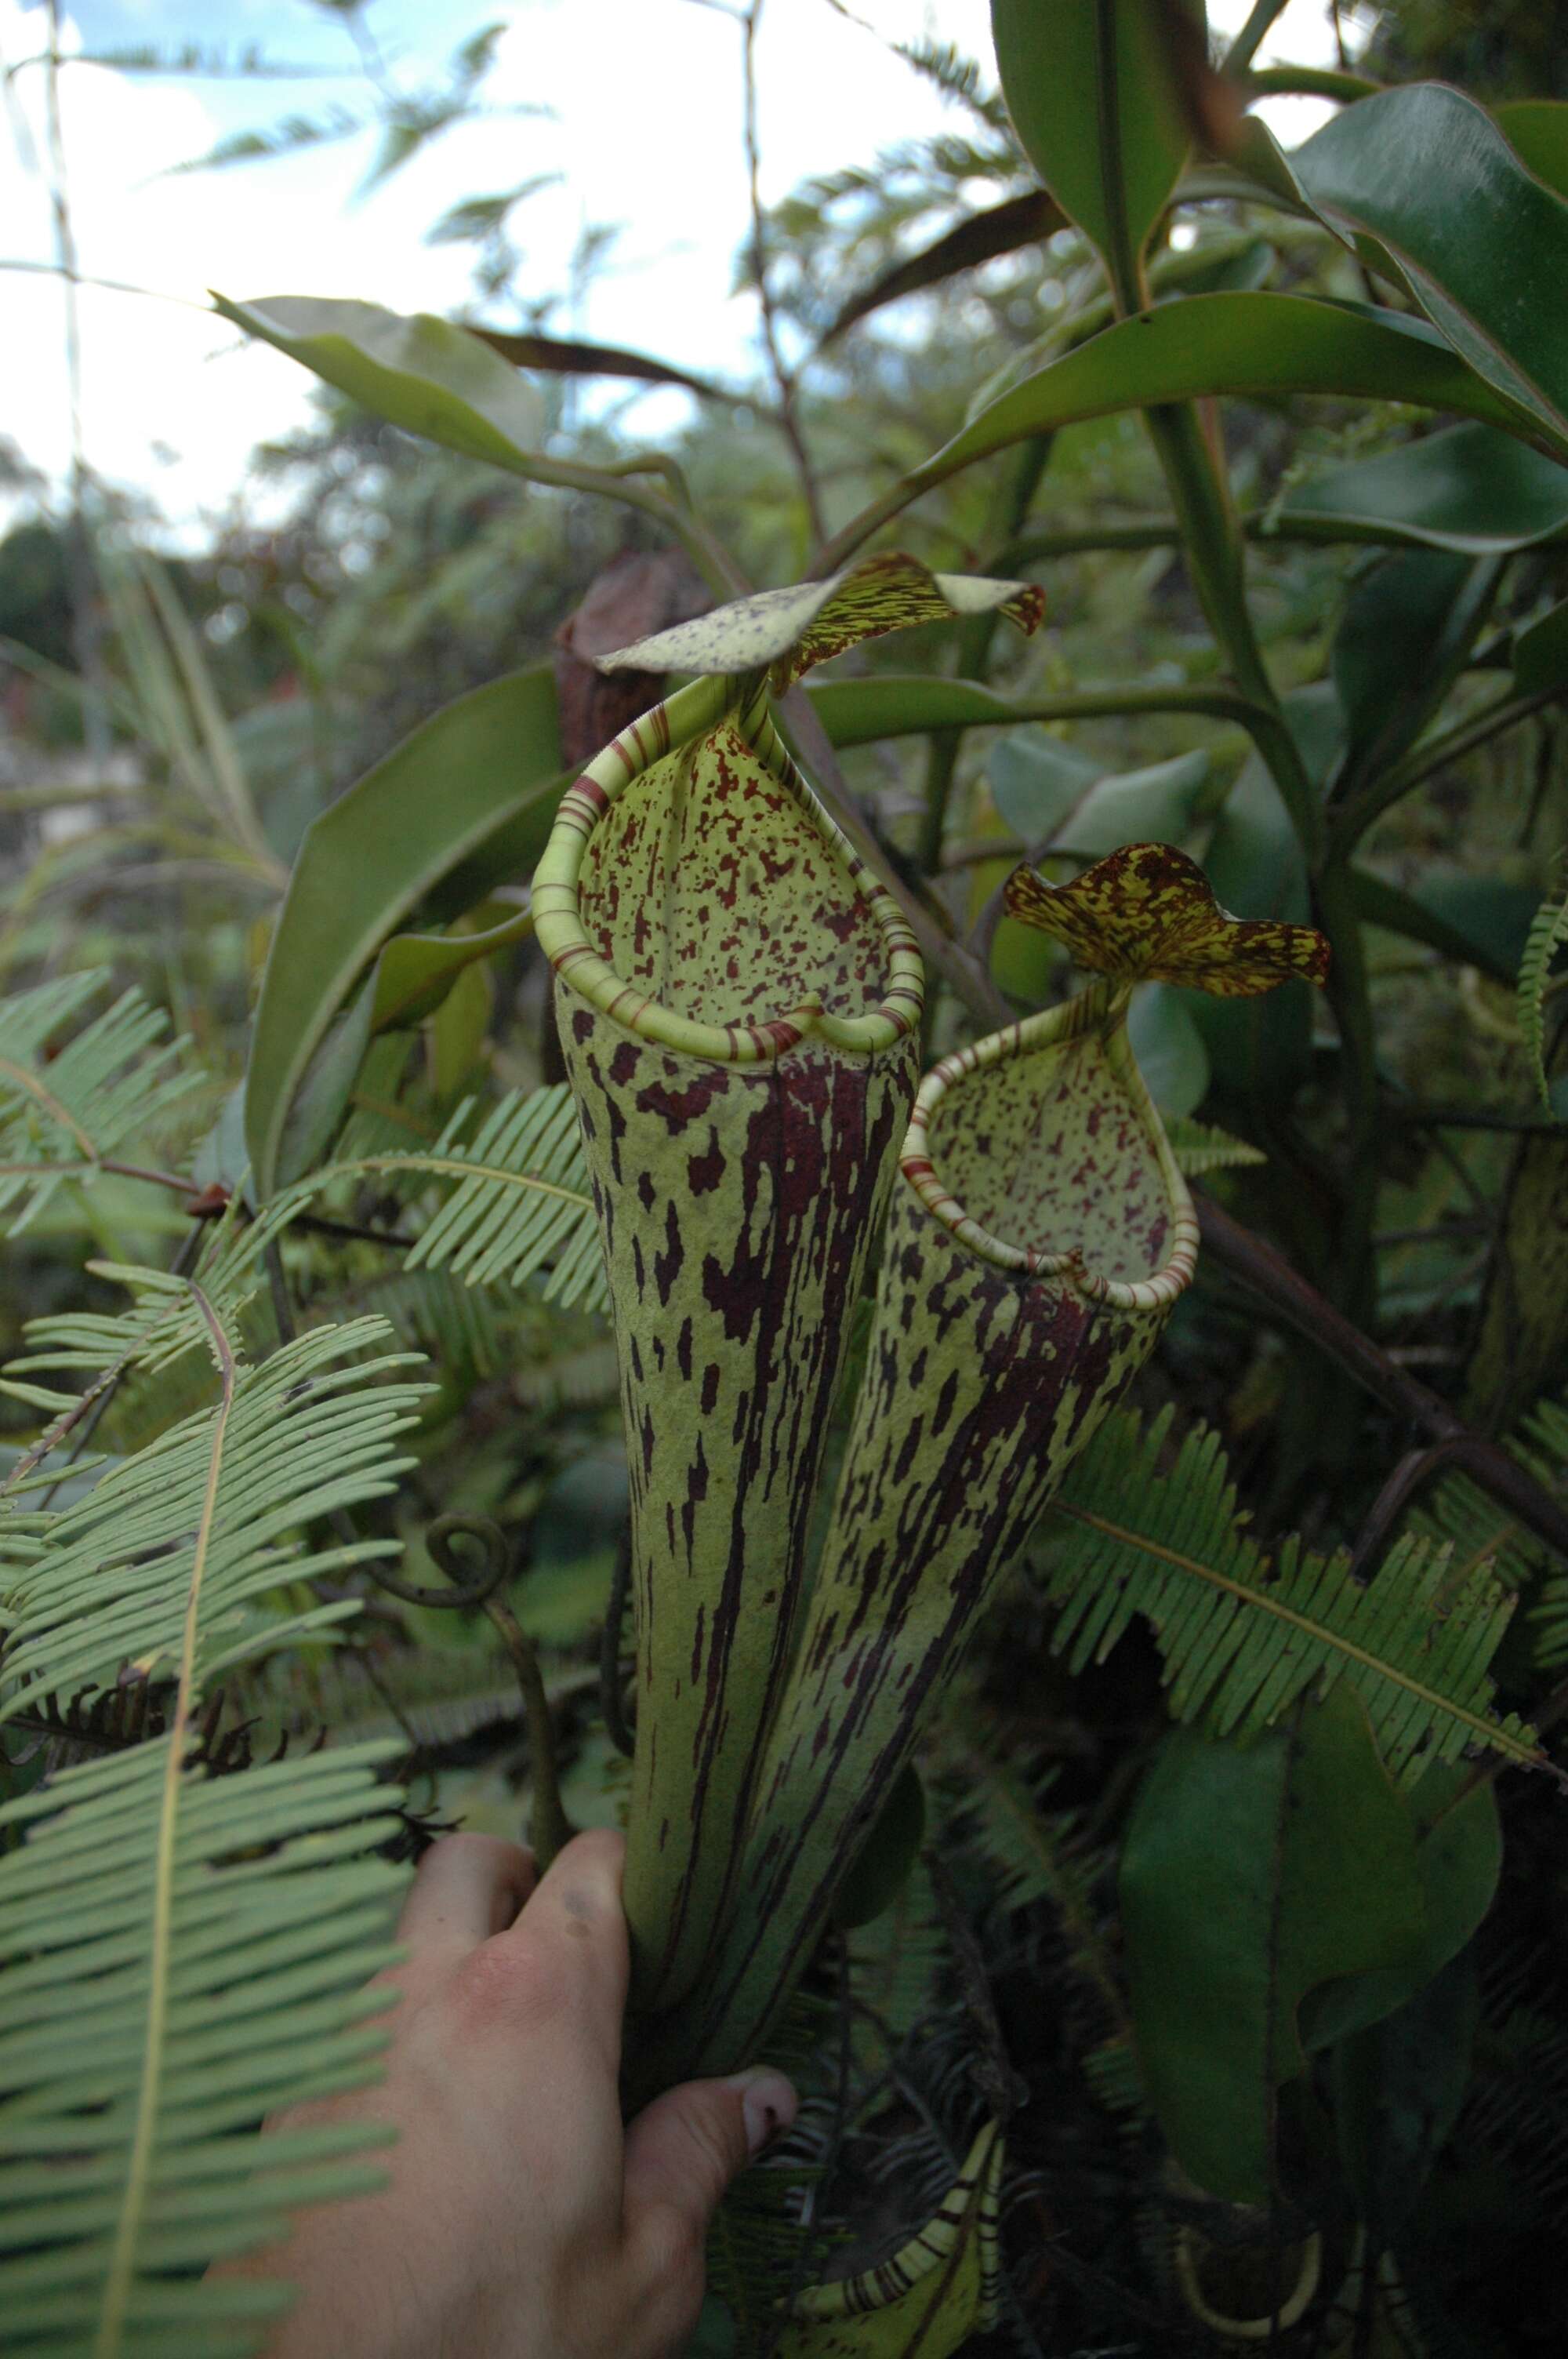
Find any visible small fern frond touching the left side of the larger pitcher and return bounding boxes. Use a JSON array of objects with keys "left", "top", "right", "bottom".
[{"left": 288, "top": 1083, "right": 608, "bottom": 1311}]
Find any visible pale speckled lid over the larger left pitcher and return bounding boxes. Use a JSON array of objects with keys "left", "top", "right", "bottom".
[{"left": 594, "top": 550, "right": 1044, "bottom": 693}]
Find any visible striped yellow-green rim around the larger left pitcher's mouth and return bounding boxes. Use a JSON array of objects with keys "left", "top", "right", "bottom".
[{"left": 533, "top": 677, "right": 924, "bottom": 1064}]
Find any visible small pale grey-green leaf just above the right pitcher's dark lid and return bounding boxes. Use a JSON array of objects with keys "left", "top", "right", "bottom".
[{"left": 985, "top": 729, "right": 1210, "bottom": 861}]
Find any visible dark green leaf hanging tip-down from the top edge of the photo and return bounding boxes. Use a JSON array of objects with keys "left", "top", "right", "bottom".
[{"left": 990, "top": 0, "right": 1203, "bottom": 281}]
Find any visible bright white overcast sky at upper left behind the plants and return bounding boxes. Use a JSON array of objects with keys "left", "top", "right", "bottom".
[{"left": 0, "top": 0, "right": 1332, "bottom": 531}]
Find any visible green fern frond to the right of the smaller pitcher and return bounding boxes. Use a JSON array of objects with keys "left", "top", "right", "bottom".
[{"left": 1042, "top": 1411, "right": 1544, "bottom": 1786}]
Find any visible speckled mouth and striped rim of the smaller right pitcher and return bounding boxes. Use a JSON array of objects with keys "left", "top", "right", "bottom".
[{"left": 898, "top": 983, "right": 1198, "bottom": 1311}]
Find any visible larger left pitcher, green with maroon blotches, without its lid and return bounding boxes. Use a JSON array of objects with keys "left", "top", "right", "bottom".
[{"left": 533, "top": 679, "right": 922, "bottom": 2010}]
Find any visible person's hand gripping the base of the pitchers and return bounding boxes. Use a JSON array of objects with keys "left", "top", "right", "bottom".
[{"left": 224, "top": 1833, "right": 795, "bottom": 2359}]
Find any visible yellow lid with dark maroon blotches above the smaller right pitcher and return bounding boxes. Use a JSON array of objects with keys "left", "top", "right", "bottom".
[{"left": 1007, "top": 845, "right": 1327, "bottom": 998}]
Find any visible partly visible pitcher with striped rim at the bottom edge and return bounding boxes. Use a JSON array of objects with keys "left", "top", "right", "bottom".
[{"left": 773, "top": 2121, "right": 1002, "bottom": 2359}]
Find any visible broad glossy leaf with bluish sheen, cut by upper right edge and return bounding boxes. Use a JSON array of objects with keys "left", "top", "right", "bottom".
[{"left": 1290, "top": 82, "right": 1568, "bottom": 449}]
